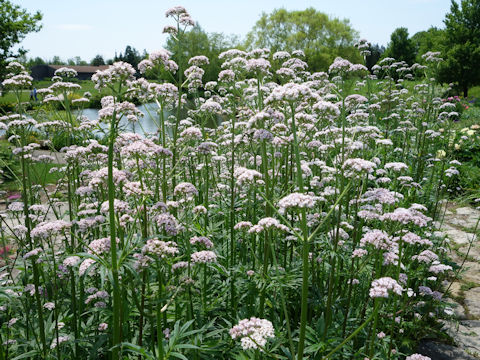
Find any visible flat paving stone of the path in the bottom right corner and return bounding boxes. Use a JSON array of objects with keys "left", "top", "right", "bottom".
[{"left": 445, "top": 320, "right": 480, "bottom": 354}]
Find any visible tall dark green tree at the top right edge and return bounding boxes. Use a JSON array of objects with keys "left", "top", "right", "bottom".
[{"left": 439, "top": 0, "right": 480, "bottom": 97}]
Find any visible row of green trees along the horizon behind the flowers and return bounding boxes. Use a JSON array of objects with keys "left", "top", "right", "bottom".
[{"left": 5, "top": 0, "right": 480, "bottom": 96}]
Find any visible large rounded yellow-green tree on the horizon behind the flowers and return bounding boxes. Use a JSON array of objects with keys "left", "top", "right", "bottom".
[{"left": 246, "top": 8, "right": 361, "bottom": 71}]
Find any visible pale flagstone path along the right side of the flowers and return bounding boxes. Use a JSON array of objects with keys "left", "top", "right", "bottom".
[{"left": 432, "top": 205, "right": 480, "bottom": 360}]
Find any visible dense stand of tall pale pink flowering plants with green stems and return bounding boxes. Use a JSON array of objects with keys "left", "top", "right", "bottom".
[{"left": 0, "top": 6, "right": 459, "bottom": 360}]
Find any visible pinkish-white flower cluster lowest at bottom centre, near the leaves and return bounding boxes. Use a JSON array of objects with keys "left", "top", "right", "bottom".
[{"left": 230, "top": 317, "right": 275, "bottom": 350}]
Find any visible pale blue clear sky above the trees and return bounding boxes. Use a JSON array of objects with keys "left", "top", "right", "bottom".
[{"left": 11, "top": 0, "right": 451, "bottom": 61}]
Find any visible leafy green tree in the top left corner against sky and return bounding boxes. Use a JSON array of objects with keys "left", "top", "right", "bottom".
[{"left": 0, "top": 0, "right": 42, "bottom": 80}]
